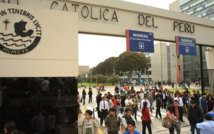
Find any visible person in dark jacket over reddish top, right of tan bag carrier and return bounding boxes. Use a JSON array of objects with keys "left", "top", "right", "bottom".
[{"left": 173, "top": 100, "right": 183, "bottom": 134}]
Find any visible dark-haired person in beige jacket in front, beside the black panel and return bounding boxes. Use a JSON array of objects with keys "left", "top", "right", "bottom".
[{"left": 78, "top": 110, "right": 99, "bottom": 134}]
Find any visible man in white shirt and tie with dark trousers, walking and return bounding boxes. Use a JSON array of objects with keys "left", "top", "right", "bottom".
[{"left": 99, "top": 97, "right": 109, "bottom": 126}]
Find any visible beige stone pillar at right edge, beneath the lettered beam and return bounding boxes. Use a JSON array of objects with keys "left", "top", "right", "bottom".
[{"left": 205, "top": 47, "right": 214, "bottom": 95}]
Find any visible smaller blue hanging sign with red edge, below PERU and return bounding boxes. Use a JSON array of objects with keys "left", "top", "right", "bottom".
[{"left": 176, "top": 36, "right": 196, "bottom": 55}]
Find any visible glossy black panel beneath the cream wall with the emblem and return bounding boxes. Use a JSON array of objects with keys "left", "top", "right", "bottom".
[{"left": 0, "top": 77, "right": 78, "bottom": 134}]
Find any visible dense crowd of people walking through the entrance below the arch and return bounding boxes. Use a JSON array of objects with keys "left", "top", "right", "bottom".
[{"left": 78, "top": 86, "right": 214, "bottom": 134}]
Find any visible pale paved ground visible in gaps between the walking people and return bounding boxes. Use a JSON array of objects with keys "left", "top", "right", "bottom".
[{"left": 78, "top": 87, "right": 190, "bottom": 134}]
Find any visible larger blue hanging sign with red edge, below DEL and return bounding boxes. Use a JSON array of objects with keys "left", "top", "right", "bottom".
[{"left": 126, "top": 30, "right": 154, "bottom": 53}]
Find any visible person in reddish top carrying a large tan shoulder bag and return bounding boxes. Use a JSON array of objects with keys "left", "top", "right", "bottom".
[{"left": 165, "top": 106, "right": 179, "bottom": 134}]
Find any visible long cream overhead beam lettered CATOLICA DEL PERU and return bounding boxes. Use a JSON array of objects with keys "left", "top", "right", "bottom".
[{"left": 0, "top": 0, "right": 214, "bottom": 46}]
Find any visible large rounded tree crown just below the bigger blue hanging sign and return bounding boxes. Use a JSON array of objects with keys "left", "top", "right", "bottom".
[{"left": 115, "top": 52, "right": 149, "bottom": 80}]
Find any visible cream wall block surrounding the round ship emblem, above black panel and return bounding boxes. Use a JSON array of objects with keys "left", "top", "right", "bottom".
[{"left": 0, "top": 4, "right": 78, "bottom": 77}]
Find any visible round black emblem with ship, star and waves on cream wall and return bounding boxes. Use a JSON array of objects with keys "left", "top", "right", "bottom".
[{"left": 0, "top": 8, "right": 42, "bottom": 55}]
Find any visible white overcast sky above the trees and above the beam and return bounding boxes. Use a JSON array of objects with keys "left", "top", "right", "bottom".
[{"left": 78, "top": 0, "right": 175, "bottom": 68}]
